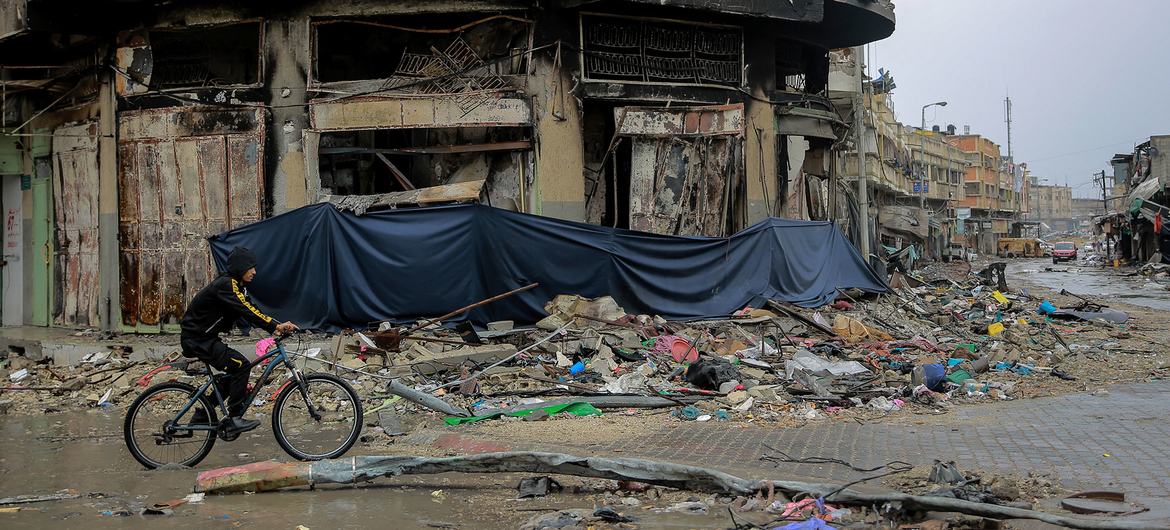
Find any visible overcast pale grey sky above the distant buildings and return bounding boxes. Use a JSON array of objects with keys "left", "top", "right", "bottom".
[{"left": 868, "top": 0, "right": 1170, "bottom": 198}]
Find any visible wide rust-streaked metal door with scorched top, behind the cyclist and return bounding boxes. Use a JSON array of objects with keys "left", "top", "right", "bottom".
[{"left": 118, "top": 108, "right": 264, "bottom": 331}]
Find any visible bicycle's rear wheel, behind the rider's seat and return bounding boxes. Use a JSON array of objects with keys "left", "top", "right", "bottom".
[{"left": 122, "top": 381, "right": 218, "bottom": 469}]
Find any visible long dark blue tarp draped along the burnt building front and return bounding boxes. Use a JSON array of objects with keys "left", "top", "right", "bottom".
[{"left": 211, "top": 204, "right": 887, "bottom": 330}]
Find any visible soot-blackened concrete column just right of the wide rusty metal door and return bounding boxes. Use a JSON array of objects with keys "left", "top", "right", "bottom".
[{"left": 264, "top": 18, "right": 317, "bottom": 215}]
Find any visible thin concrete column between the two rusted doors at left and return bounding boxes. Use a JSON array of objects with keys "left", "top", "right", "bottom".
[{"left": 98, "top": 70, "right": 122, "bottom": 331}]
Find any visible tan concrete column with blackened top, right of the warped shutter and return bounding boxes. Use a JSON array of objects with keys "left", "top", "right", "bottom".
[{"left": 743, "top": 25, "right": 779, "bottom": 223}]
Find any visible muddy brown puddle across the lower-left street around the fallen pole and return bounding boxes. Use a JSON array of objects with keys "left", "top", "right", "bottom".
[{"left": 0, "top": 408, "right": 730, "bottom": 529}]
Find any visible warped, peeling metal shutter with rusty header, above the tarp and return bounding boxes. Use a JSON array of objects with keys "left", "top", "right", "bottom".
[{"left": 615, "top": 105, "right": 743, "bottom": 236}]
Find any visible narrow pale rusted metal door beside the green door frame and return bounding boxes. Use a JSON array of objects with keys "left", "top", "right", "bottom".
[{"left": 53, "top": 122, "right": 98, "bottom": 328}]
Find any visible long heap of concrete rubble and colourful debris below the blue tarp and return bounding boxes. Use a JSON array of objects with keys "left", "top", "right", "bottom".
[{"left": 301, "top": 260, "right": 1151, "bottom": 440}]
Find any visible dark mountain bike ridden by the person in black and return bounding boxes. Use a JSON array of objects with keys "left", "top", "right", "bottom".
[{"left": 123, "top": 329, "right": 363, "bottom": 469}]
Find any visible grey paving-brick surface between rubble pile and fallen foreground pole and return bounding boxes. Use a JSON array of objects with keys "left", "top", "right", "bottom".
[{"left": 399, "top": 381, "right": 1170, "bottom": 512}]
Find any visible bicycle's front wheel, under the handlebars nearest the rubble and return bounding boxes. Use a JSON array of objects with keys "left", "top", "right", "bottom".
[{"left": 273, "top": 373, "right": 362, "bottom": 460}]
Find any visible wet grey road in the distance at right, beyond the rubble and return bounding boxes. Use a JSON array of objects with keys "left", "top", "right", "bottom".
[{"left": 1007, "top": 259, "right": 1170, "bottom": 310}]
